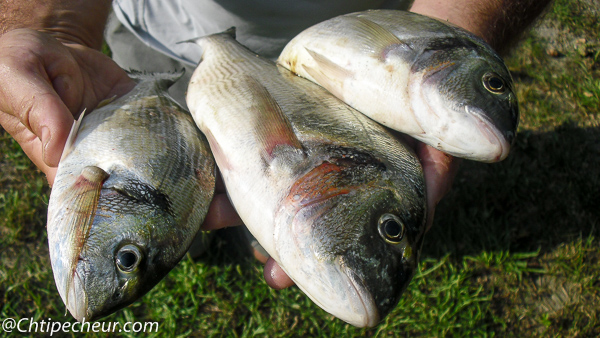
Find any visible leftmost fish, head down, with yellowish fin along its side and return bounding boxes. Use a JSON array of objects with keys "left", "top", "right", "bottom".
[{"left": 47, "top": 72, "right": 216, "bottom": 321}]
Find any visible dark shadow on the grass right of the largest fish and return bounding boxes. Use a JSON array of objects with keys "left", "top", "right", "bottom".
[{"left": 423, "top": 124, "right": 600, "bottom": 258}]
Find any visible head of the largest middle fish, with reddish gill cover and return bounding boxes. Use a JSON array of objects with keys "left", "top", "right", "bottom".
[{"left": 275, "top": 149, "right": 425, "bottom": 327}]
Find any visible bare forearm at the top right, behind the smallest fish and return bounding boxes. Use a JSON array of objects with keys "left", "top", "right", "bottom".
[{"left": 411, "top": 0, "right": 551, "bottom": 53}]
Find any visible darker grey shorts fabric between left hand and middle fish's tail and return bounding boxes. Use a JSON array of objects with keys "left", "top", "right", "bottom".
[{"left": 104, "top": 13, "right": 195, "bottom": 107}]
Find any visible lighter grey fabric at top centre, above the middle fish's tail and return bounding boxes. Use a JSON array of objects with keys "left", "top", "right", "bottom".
[{"left": 112, "top": 0, "right": 412, "bottom": 65}]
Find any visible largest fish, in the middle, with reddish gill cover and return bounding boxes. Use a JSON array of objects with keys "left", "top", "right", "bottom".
[{"left": 186, "top": 29, "right": 426, "bottom": 327}]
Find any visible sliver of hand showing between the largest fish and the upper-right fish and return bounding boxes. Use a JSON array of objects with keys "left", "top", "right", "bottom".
[{"left": 415, "top": 142, "right": 460, "bottom": 230}]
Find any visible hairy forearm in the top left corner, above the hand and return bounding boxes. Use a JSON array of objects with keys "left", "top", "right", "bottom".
[{"left": 0, "top": 0, "right": 111, "bottom": 49}]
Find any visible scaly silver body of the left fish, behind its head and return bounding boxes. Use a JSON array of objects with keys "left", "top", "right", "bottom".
[{"left": 57, "top": 94, "right": 210, "bottom": 219}]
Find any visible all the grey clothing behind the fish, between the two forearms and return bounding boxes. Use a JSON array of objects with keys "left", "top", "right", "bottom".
[{"left": 105, "top": 0, "right": 412, "bottom": 107}]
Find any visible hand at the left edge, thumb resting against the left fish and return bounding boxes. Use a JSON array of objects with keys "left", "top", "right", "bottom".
[{"left": 0, "top": 28, "right": 135, "bottom": 185}]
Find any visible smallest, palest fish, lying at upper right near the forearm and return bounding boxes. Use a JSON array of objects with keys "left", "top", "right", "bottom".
[{"left": 278, "top": 10, "right": 519, "bottom": 162}]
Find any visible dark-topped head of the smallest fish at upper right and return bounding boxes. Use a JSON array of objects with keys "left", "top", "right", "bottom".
[{"left": 409, "top": 37, "right": 519, "bottom": 162}]
